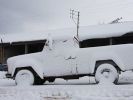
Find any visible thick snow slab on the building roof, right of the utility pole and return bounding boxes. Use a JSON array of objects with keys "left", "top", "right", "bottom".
[{"left": 79, "top": 22, "right": 133, "bottom": 41}]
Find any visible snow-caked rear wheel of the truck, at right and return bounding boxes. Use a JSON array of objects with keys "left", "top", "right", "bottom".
[{"left": 95, "top": 63, "right": 119, "bottom": 84}]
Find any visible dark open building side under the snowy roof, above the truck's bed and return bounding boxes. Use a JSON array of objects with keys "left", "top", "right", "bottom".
[{"left": 79, "top": 32, "right": 133, "bottom": 48}]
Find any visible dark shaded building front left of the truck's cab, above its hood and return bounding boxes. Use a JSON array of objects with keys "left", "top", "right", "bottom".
[{"left": 0, "top": 42, "right": 45, "bottom": 63}]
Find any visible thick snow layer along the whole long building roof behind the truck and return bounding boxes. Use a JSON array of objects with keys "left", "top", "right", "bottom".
[{"left": 0, "top": 22, "right": 133, "bottom": 43}]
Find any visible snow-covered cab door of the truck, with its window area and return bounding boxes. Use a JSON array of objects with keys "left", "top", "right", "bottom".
[{"left": 44, "top": 41, "right": 76, "bottom": 76}]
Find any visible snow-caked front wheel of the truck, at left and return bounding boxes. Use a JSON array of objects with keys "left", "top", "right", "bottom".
[{"left": 15, "top": 69, "right": 35, "bottom": 85}]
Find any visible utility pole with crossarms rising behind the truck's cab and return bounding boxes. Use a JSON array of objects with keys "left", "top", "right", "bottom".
[{"left": 70, "top": 9, "right": 80, "bottom": 39}]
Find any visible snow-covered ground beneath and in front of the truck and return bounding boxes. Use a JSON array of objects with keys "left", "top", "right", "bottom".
[{"left": 0, "top": 72, "right": 133, "bottom": 100}]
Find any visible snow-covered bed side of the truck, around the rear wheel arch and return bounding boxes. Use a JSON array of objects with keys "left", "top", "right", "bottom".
[{"left": 77, "top": 44, "right": 133, "bottom": 73}]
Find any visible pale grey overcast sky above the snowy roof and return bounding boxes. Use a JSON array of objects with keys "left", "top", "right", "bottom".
[{"left": 0, "top": 0, "right": 133, "bottom": 33}]
